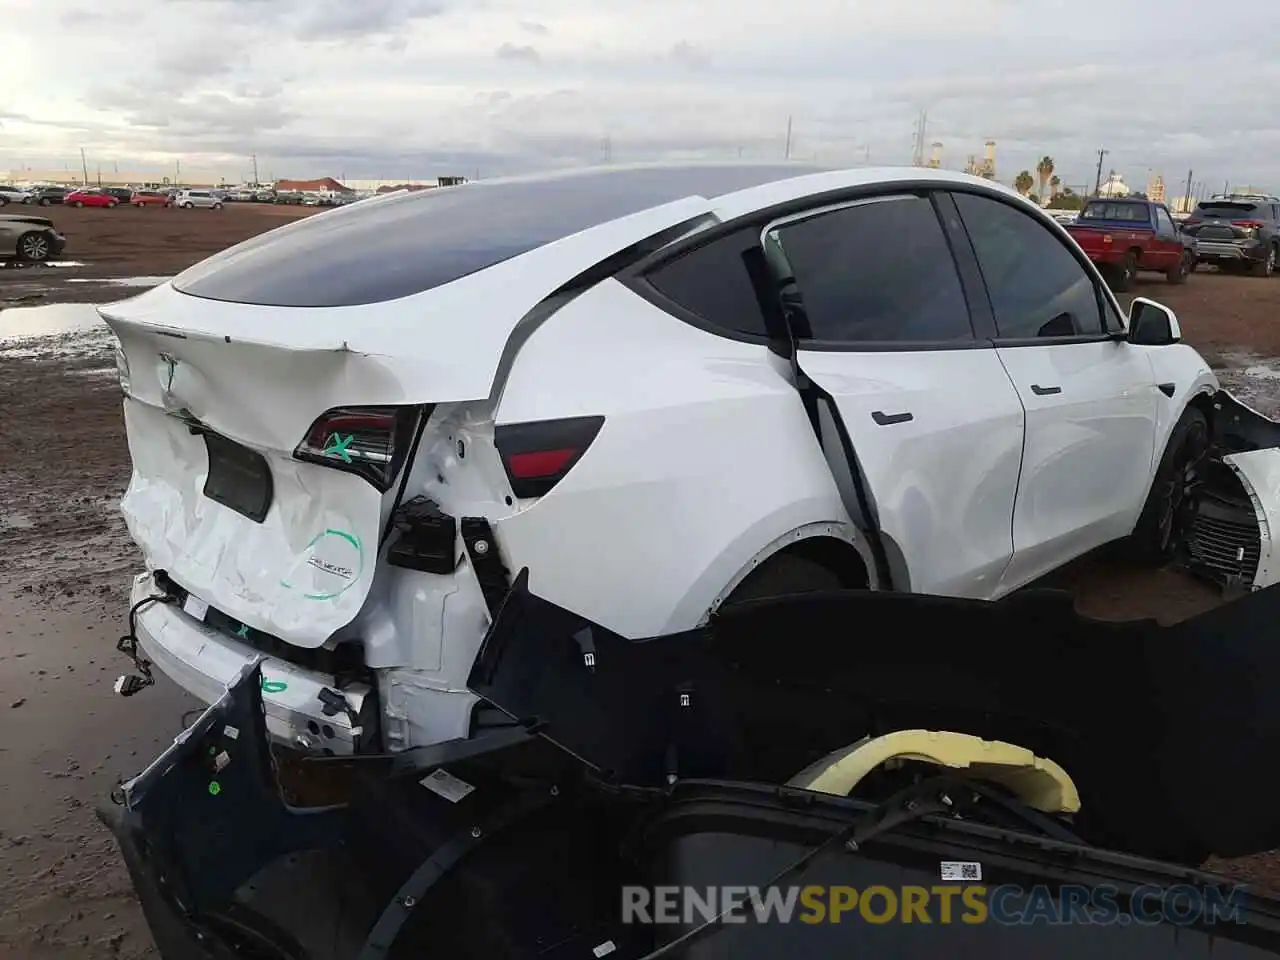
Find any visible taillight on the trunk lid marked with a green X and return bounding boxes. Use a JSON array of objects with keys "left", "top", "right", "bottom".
[{"left": 293, "top": 407, "right": 421, "bottom": 492}]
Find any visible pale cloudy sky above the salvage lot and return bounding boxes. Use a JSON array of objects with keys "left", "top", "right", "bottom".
[{"left": 0, "top": 0, "right": 1280, "bottom": 195}]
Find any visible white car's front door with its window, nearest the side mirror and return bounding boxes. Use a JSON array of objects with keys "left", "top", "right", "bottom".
[{"left": 955, "top": 193, "right": 1158, "bottom": 591}]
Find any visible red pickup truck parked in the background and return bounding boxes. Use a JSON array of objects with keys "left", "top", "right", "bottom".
[{"left": 1066, "top": 197, "right": 1196, "bottom": 291}]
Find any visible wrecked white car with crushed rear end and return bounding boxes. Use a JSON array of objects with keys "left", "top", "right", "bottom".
[{"left": 101, "top": 164, "right": 1280, "bottom": 754}]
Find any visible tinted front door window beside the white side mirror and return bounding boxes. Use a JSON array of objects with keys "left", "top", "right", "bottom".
[{"left": 956, "top": 193, "right": 1102, "bottom": 338}]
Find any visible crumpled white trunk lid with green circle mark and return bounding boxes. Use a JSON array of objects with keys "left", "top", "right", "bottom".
[{"left": 99, "top": 197, "right": 708, "bottom": 646}]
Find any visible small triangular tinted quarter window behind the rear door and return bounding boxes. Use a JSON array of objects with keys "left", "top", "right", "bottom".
[{"left": 646, "top": 227, "right": 767, "bottom": 337}]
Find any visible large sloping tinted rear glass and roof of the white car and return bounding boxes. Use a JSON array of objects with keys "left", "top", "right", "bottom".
[{"left": 174, "top": 164, "right": 820, "bottom": 307}]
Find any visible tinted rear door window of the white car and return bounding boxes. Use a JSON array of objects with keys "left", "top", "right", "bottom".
[{"left": 773, "top": 197, "right": 973, "bottom": 343}]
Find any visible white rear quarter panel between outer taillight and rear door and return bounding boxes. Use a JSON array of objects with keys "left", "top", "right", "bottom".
[{"left": 495, "top": 280, "right": 855, "bottom": 637}]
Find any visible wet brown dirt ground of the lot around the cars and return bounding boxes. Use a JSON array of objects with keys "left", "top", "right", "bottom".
[{"left": 0, "top": 213, "right": 1280, "bottom": 960}]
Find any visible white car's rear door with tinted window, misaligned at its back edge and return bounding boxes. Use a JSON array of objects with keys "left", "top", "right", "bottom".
[{"left": 762, "top": 195, "right": 1023, "bottom": 598}]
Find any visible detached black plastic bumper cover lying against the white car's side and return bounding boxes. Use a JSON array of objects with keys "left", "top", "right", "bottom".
[{"left": 468, "top": 571, "right": 1280, "bottom": 863}]
